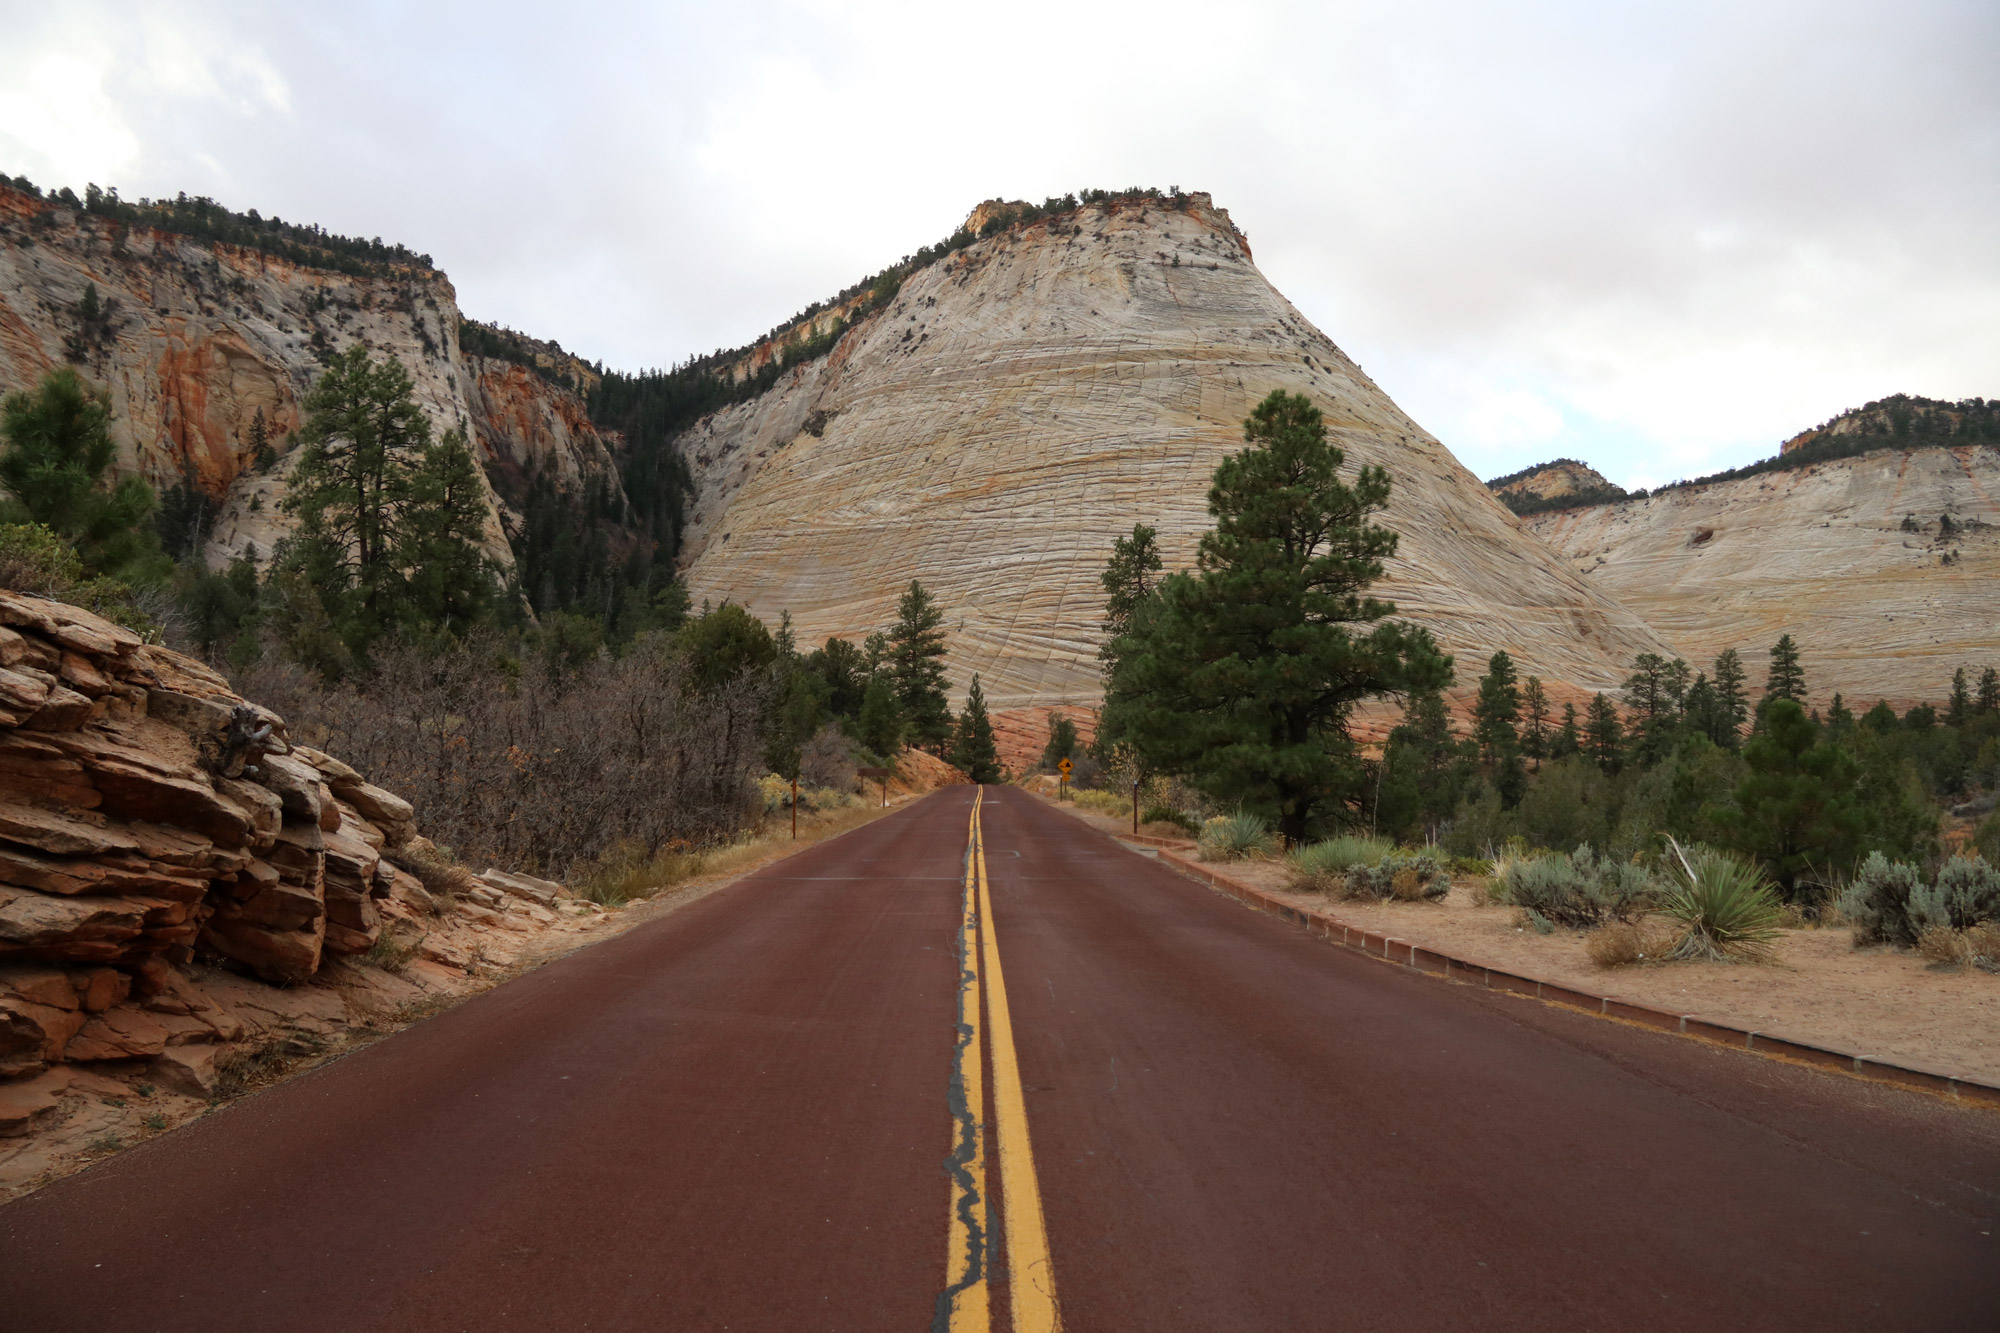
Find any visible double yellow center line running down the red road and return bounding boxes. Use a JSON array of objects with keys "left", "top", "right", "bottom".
[{"left": 932, "top": 787, "right": 1062, "bottom": 1333}]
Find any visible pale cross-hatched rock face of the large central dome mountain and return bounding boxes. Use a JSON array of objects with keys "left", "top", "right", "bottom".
[{"left": 682, "top": 194, "right": 1664, "bottom": 709}]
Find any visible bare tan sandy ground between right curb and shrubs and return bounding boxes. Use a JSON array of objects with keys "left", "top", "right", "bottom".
[{"left": 1062, "top": 792, "right": 2000, "bottom": 1085}]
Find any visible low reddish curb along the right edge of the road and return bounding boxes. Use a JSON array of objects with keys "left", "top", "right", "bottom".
[{"left": 1108, "top": 833, "right": 2000, "bottom": 1111}]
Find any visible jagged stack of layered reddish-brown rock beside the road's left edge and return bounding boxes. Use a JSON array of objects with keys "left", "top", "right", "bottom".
[{"left": 0, "top": 590, "right": 588, "bottom": 1133}]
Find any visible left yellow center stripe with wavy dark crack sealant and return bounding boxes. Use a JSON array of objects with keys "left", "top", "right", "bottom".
[{"left": 932, "top": 793, "right": 992, "bottom": 1333}]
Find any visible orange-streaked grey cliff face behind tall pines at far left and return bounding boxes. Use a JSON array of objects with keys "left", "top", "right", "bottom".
[{"left": 0, "top": 184, "right": 618, "bottom": 566}]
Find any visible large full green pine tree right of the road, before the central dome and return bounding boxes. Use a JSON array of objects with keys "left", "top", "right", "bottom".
[{"left": 1104, "top": 390, "right": 1448, "bottom": 841}]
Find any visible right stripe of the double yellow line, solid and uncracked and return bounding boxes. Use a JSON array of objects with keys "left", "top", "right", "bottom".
[{"left": 972, "top": 793, "right": 1062, "bottom": 1333}]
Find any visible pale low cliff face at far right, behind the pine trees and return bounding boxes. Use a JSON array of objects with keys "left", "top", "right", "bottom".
[{"left": 1524, "top": 444, "right": 2000, "bottom": 709}]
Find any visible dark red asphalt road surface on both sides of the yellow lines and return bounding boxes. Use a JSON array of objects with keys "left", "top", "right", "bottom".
[{"left": 0, "top": 789, "right": 2000, "bottom": 1333}]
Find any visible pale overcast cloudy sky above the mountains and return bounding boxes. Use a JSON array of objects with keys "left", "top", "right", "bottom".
[{"left": 0, "top": 0, "right": 2000, "bottom": 486}]
